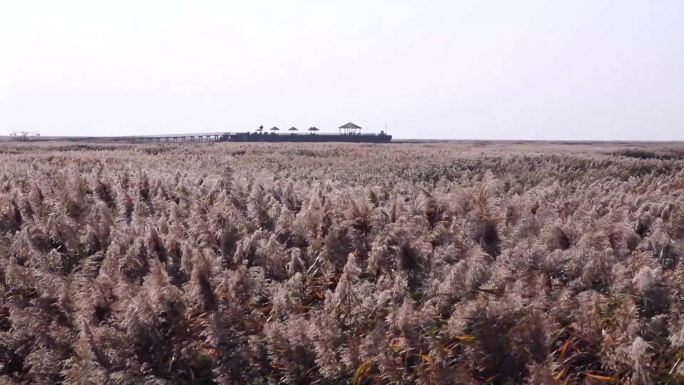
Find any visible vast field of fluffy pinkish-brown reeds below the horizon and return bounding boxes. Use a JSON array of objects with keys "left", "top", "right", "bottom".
[{"left": 0, "top": 142, "right": 684, "bottom": 385}]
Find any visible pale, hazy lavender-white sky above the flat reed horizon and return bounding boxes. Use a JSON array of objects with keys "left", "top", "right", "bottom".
[{"left": 0, "top": 0, "right": 684, "bottom": 140}]
